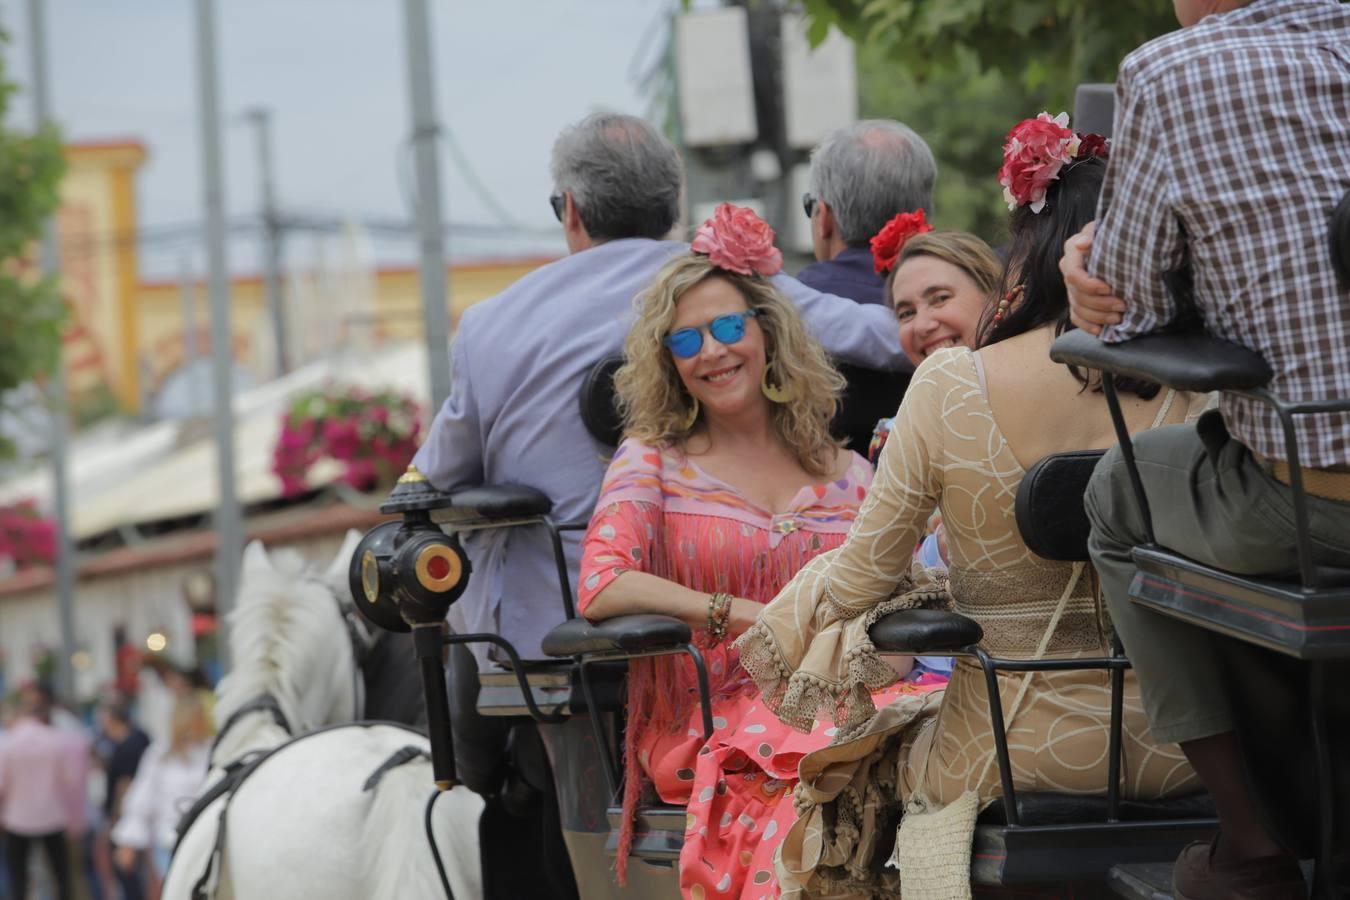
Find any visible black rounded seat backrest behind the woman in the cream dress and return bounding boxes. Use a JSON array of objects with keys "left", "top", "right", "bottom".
[{"left": 1014, "top": 451, "right": 1103, "bottom": 563}]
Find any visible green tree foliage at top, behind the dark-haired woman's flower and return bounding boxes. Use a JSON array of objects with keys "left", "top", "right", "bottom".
[{"left": 803, "top": 0, "right": 1176, "bottom": 243}]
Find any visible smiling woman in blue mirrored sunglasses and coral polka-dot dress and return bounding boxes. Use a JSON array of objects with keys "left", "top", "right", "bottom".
[{"left": 578, "top": 206, "right": 925, "bottom": 897}]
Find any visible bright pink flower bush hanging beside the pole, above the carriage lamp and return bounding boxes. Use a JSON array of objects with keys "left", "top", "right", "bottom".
[{"left": 271, "top": 385, "right": 421, "bottom": 497}]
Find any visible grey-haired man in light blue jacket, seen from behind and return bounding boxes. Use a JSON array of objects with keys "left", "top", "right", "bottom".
[{"left": 413, "top": 113, "right": 907, "bottom": 897}]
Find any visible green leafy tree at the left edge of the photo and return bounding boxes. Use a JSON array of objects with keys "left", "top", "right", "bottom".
[{"left": 0, "top": 30, "right": 65, "bottom": 456}]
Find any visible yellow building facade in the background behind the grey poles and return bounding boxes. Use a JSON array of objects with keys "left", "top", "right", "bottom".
[{"left": 57, "top": 140, "right": 552, "bottom": 413}]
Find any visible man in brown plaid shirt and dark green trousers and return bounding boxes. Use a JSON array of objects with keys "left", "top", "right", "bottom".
[{"left": 1061, "top": 0, "right": 1350, "bottom": 900}]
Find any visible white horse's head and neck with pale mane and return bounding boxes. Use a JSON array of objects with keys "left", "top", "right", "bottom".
[{"left": 216, "top": 532, "right": 373, "bottom": 734}]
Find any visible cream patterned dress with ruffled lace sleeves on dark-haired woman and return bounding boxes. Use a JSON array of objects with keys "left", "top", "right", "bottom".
[{"left": 738, "top": 348, "right": 1199, "bottom": 896}]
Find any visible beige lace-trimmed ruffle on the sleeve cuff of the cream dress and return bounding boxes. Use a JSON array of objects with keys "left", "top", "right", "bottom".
[{"left": 737, "top": 588, "right": 949, "bottom": 743}]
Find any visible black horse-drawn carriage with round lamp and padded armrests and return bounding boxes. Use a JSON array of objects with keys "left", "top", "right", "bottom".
[{"left": 342, "top": 184, "right": 1350, "bottom": 897}]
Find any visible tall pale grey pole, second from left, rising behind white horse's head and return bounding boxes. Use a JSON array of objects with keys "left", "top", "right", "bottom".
[{"left": 196, "top": 0, "right": 243, "bottom": 669}]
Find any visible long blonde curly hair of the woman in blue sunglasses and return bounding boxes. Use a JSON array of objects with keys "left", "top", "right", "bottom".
[{"left": 614, "top": 254, "right": 845, "bottom": 478}]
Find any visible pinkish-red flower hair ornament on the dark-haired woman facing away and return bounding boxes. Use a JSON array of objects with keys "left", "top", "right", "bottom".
[{"left": 999, "top": 112, "right": 1107, "bottom": 213}]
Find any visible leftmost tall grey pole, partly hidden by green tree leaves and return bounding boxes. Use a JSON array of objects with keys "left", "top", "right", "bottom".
[{"left": 28, "top": 0, "right": 76, "bottom": 702}]
